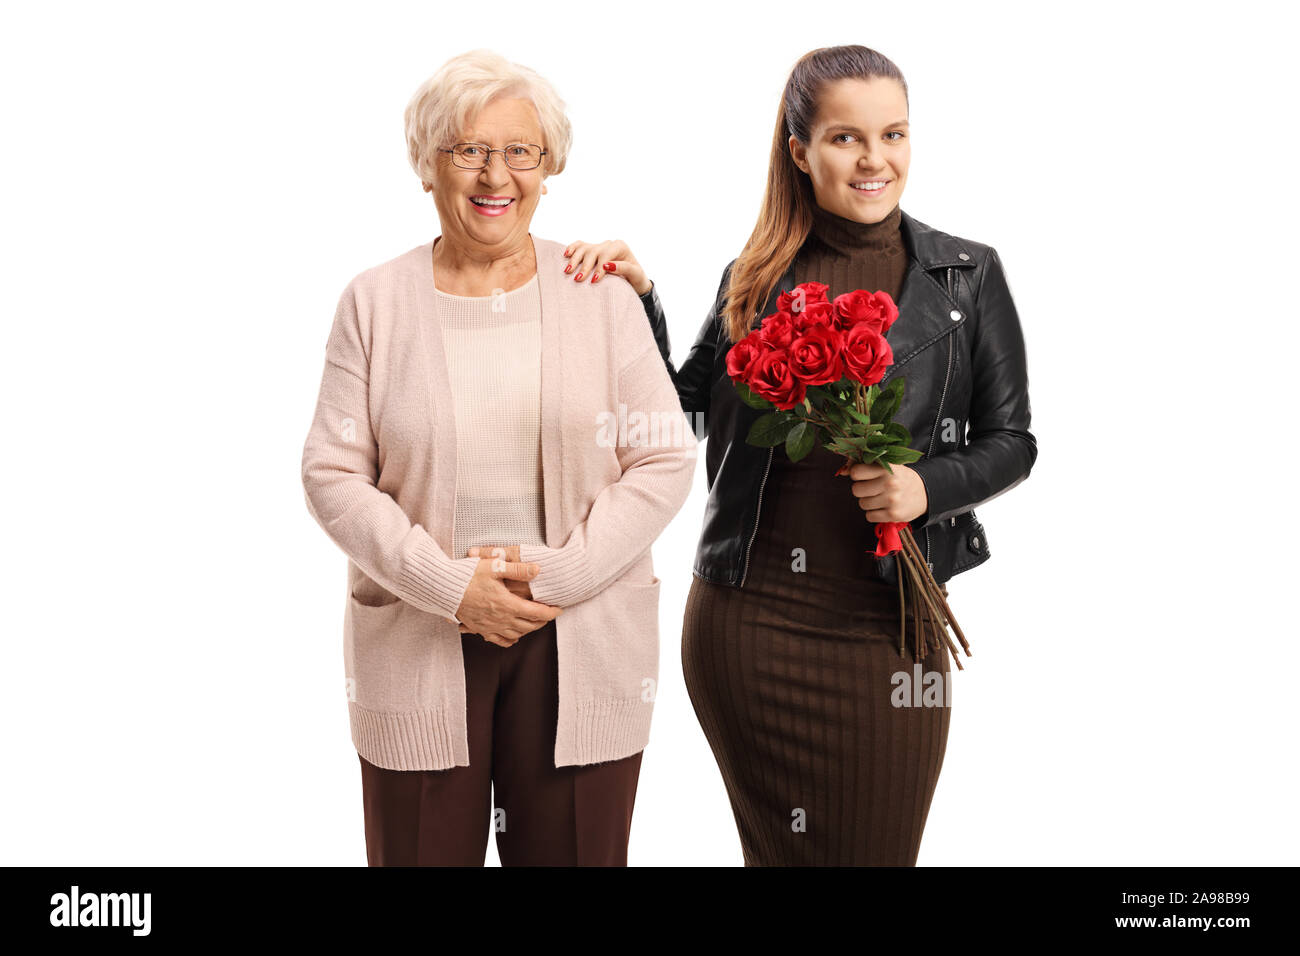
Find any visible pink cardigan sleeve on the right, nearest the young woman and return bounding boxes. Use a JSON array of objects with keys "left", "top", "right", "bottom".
[{"left": 519, "top": 286, "right": 697, "bottom": 607}]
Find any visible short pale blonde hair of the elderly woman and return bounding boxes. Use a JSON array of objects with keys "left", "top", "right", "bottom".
[{"left": 406, "top": 49, "right": 573, "bottom": 183}]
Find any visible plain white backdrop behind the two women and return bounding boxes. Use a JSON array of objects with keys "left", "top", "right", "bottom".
[{"left": 0, "top": 0, "right": 1300, "bottom": 865}]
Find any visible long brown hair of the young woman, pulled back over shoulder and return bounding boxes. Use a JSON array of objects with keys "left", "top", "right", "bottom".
[{"left": 723, "top": 46, "right": 907, "bottom": 342}]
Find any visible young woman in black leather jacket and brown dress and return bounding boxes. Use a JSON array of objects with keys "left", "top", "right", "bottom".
[{"left": 568, "top": 46, "right": 1037, "bottom": 865}]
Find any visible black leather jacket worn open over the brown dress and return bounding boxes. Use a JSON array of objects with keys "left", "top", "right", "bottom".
[{"left": 641, "top": 212, "right": 1037, "bottom": 588}]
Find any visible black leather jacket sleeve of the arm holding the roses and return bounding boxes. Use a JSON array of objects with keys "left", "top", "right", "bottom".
[{"left": 911, "top": 247, "right": 1039, "bottom": 528}]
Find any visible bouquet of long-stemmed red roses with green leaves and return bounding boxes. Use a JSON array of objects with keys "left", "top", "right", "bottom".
[{"left": 727, "top": 282, "right": 971, "bottom": 669}]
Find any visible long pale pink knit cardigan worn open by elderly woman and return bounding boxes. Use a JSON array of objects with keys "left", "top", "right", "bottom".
[{"left": 302, "top": 237, "right": 697, "bottom": 770}]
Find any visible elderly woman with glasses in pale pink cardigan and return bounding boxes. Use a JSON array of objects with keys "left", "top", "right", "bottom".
[{"left": 303, "top": 51, "right": 696, "bottom": 865}]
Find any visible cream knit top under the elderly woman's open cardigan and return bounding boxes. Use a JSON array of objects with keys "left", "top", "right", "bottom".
[{"left": 436, "top": 273, "right": 546, "bottom": 558}]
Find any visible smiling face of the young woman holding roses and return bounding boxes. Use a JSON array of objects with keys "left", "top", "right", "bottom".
[{"left": 789, "top": 77, "right": 911, "bottom": 222}]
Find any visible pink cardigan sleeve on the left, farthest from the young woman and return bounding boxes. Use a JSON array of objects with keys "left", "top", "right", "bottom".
[{"left": 302, "top": 284, "right": 478, "bottom": 620}]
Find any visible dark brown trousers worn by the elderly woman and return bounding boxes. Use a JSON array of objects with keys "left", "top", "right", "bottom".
[{"left": 358, "top": 622, "right": 641, "bottom": 866}]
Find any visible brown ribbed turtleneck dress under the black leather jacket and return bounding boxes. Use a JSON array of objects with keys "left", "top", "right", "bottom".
[{"left": 683, "top": 206, "right": 952, "bottom": 866}]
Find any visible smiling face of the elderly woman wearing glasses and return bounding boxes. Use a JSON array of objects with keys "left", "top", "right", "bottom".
[{"left": 432, "top": 99, "right": 546, "bottom": 252}]
